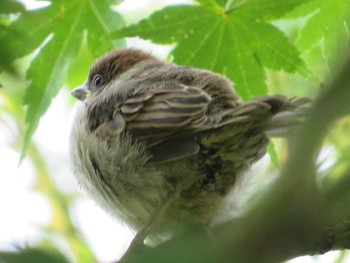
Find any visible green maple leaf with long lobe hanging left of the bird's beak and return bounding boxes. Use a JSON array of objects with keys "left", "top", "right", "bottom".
[{"left": 0, "top": 0, "right": 124, "bottom": 159}]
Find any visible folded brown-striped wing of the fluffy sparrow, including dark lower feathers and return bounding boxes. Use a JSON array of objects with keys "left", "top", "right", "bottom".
[{"left": 91, "top": 81, "right": 215, "bottom": 161}]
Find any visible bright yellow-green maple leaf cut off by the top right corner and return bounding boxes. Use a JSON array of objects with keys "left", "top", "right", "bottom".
[{"left": 296, "top": 0, "right": 350, "bottom": 68}]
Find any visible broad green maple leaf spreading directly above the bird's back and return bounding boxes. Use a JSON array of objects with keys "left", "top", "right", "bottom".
[{"left": 111, "top": 3, "right": 314, "bottom": 99}]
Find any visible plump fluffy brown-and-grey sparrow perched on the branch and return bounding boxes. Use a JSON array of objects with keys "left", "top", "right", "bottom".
[{"left": 70, "top": 48, "right": 308, "bottom": 249}]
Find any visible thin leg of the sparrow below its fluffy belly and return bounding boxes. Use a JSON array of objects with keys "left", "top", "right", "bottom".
[{"left": 123, "top": 188, "right": 178, "bottom": 258}]
